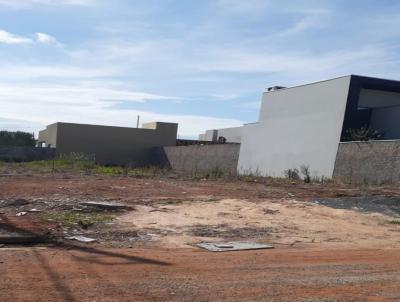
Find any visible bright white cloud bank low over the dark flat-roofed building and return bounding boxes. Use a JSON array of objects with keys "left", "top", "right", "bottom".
[{"left": 0, "top": 83, "right": 243, "bottom": 137}]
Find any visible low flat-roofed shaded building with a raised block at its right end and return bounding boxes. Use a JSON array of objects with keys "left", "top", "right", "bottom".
[{"left": 39, "top": 123, "right": 178, "bottom": 166}]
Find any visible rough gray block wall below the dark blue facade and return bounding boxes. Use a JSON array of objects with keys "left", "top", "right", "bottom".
[{"left": 333, "top": 140, "right": 400, "bottom": 184}]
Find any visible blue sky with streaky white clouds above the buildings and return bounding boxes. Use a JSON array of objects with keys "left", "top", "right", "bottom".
[{"left": 0, "top": 0, "right": 400, "bottom": 138}]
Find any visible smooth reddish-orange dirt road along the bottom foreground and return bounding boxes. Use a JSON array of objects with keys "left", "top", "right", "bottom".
[{"left": 0, "top": 247, "right": 400, "bottom": 302}]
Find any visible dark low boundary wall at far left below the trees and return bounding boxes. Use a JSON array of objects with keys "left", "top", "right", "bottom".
[{"left": 0, "top": 146, "right": 56, "bottom": 162}]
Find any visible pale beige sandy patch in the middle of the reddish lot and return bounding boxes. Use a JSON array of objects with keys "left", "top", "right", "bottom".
[{"left": 118, "top": 199, "right": 400, "bottom": 248}]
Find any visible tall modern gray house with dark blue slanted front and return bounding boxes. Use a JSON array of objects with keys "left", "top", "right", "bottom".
[{"left": 238, "top": 75, "right": 400, "bottom": 178}]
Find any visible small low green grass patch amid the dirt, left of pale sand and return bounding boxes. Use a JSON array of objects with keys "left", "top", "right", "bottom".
[{"left": 38, "top": 211, "right": 114, "bottom": 226}]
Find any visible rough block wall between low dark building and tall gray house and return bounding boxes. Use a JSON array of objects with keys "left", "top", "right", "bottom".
[{"left": 162, "top": 144, "right": 240, "bottom": 175}]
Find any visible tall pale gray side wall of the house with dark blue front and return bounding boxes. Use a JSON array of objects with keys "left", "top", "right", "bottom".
[{"left": 238, "top": 76, "right": 351, "bottom": 177}]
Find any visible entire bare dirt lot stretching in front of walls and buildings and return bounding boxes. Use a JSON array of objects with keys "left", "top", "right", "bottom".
[{"left": 0, "top": 173, "right": 400, "bottom": 301}]
